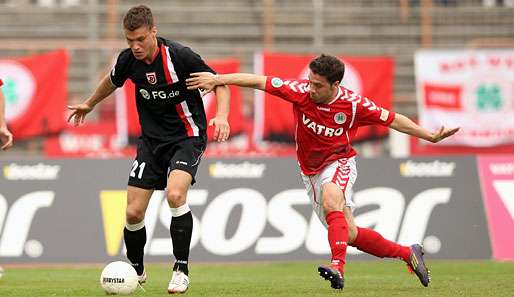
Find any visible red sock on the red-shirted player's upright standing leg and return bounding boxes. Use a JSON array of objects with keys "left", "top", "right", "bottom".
[{"left": 325, "top": 211, "right": 348, "bottom": 274}]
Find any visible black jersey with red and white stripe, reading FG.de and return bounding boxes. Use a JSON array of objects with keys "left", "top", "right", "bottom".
[{"left": 111, "top": 37, "right": 215, "bottom": 142}]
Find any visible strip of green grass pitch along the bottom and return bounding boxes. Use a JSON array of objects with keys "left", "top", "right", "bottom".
[{"left": 0, "top": 261, "right": 514, "bottom": 297}]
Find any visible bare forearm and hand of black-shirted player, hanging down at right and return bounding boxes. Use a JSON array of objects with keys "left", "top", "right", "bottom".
[{"left": 209, "top": 86, "right": 230, "bottom": 142}]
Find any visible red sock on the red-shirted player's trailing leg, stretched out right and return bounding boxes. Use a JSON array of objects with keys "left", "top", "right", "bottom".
[{"left": 352, "top": 227, "right": 410, "bottom": 262}]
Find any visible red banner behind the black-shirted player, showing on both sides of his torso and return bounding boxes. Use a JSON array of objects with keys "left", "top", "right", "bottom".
[{"left": 117, "top": 59, "right": 244, "bottom": 140}]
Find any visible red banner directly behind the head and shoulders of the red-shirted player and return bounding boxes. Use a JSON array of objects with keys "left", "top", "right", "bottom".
[{"left": 254, "top": 53, "right": 394, "bottom": 142}]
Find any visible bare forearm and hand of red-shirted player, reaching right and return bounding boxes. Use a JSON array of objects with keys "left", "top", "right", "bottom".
[{"left": 390, "top": 113, "right": 460, "bottom": 143}]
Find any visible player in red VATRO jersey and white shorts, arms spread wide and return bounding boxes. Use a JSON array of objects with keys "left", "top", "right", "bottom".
[{"left": 186, "top": 55, "right": 459, "bottom": 289}]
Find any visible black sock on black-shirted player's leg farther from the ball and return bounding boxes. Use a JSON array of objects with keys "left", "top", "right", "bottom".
[{"left": 170, "top": 211, "right": 193, "bottom": 275}]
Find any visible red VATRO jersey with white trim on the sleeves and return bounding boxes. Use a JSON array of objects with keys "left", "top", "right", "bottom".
[{"left": 265, "top": 77, "right": 395, "bottom": 175}]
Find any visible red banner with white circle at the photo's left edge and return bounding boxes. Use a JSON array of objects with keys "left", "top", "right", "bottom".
[{"left": 0, "top": 50, "right": 69, "bottom": 139}]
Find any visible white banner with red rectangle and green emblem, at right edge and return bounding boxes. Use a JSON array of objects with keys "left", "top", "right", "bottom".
[{"left": 415, "top": 50, "right": 514, "bottom": 147}]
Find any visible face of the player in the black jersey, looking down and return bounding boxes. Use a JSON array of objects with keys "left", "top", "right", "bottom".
[{"left": 124, "top": 26, "right": 157, "bottom": 60}]
